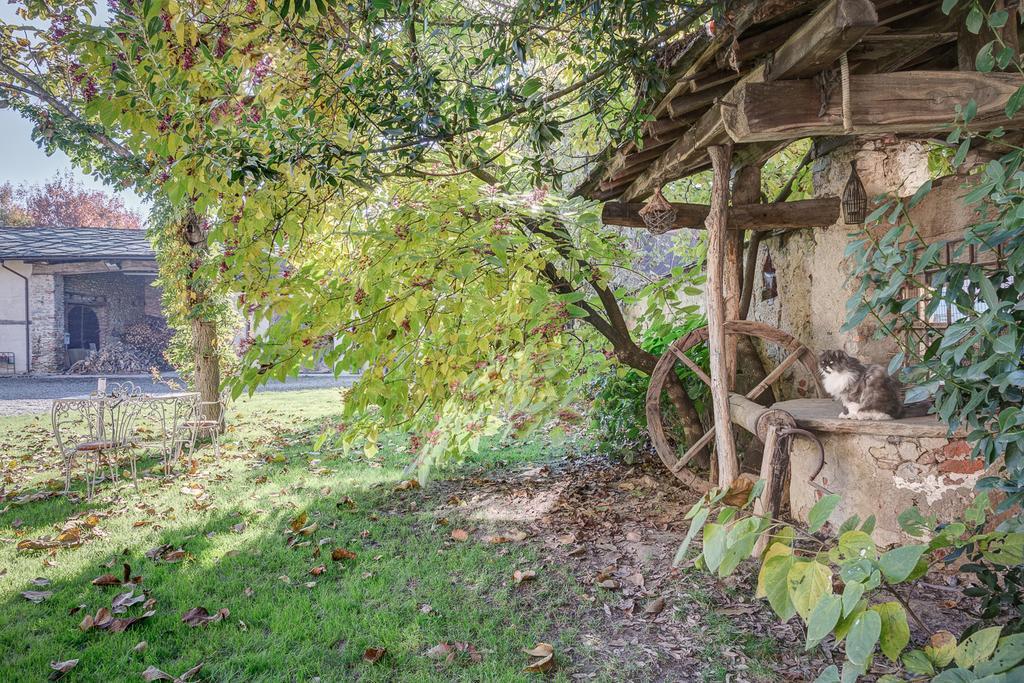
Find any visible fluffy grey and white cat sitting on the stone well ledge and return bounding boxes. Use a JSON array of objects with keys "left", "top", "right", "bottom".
[{"left": 818, "top": 351, "right": 903, "bottom": 420}]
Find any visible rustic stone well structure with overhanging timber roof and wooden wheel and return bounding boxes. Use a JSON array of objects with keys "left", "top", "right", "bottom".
[{"left": 577, "top": 0, "right": 1022, "bottom": 543}]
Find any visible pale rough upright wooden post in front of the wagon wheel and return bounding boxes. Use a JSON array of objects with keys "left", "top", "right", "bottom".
[{"left": 706, "top": 144, "right": 739, "bottom": 488}]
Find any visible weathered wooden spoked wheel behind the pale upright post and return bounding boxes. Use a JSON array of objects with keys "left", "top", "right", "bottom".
[{"left": 646, "top": 321, "right": 824, "bottom": 489}]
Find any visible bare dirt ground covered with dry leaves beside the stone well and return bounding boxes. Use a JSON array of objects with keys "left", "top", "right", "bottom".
[{"left": 393, "top": 456, "right": 978, "bottom": 683}]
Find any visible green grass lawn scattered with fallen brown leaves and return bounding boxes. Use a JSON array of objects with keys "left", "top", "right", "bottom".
[{"left": 0, "top": 390, "right": 573, "bottom": 681}]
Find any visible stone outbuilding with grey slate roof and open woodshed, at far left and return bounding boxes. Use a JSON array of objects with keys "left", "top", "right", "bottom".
[{"left": 0, "top": 227, "right": 162, "bottom": 374}]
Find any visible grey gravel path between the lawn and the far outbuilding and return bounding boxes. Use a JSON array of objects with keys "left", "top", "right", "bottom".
[{"left": 0, "top": 375, "right": 355, "bottom": 417}]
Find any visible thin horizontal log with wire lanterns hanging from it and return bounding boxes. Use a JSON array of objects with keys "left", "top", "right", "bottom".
[{"left": 601, "top": 197, "right": 840, "bottom": 231}]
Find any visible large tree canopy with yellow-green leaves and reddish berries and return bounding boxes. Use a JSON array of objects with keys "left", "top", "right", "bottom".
[{"left": 5, "top": 0, "right": 709, "bottom": 471}]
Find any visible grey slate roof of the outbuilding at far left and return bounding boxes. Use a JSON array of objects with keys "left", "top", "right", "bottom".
[{"left": 0, "top": 227, "right": 156, "bottom": 261}]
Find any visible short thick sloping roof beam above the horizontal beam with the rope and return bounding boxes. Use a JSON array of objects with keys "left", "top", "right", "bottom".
[{"left": 765, "top": 0, "right": 879, "bottom": 81}]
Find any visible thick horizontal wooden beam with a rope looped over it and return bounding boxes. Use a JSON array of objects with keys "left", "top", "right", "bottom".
[{"left": 720, "top": 71, "right": 1024, "bottom": 143}]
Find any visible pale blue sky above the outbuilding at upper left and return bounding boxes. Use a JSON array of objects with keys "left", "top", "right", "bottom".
[{"left": 0, "top": 0, "right": 147, "bottom": 218}]
